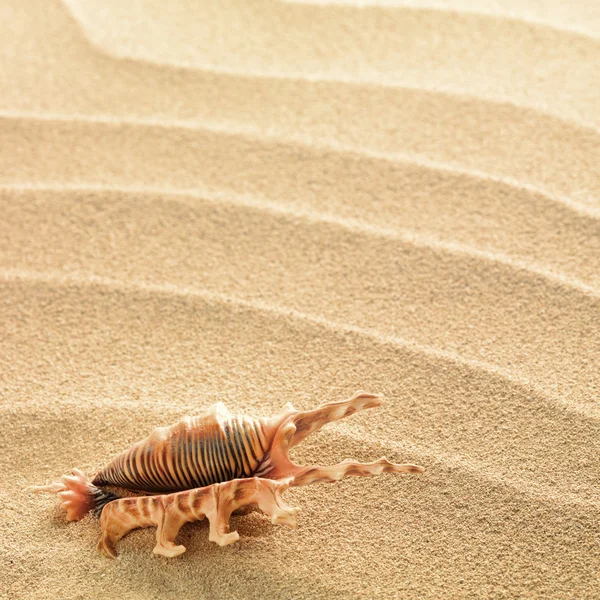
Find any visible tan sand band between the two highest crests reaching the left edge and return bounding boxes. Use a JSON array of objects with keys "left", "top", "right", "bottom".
[{"left": 0, "top": 117, "right": 600, "bottom": 288}]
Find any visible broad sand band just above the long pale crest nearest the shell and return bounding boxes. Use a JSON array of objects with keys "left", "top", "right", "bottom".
[{"left": 3, "top": 185, "right": 600, "bottom": 404}]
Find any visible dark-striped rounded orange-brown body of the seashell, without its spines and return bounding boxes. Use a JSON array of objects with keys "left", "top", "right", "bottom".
[{"left": 93, "top": 403, "right": 268, "bottom": 493}]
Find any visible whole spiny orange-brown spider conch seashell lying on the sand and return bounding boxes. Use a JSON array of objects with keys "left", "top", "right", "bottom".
[{"left": 29, "top": 392, "right": 423, "bottom": 557}]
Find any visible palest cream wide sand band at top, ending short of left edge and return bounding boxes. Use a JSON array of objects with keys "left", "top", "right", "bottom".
[{"left": 66, "top": 0, "right": 600, "bottom": 126}]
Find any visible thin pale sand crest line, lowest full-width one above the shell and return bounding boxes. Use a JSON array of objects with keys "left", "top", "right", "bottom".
[{"left": 0, "top": 268, "right": 600, "bottom": 419}]
